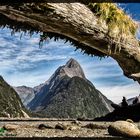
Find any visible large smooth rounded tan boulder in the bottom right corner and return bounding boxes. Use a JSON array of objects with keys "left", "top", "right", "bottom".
[{"left": 108, "top": 121, "right": 140, "bottom": 138}]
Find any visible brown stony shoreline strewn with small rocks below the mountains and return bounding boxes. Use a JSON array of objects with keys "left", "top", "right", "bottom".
[{"left": 0, "top": 118, "right": 139, "bottom": 140}]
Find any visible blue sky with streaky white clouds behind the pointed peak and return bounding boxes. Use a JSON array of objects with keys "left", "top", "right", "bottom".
[{"left": 0, "top": 4, "right": 140, "bottom": 102}]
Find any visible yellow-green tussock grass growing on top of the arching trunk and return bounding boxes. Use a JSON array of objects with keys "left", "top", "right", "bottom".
[{"left": 88, "top": 3, "right": 138, "bottom": 36}]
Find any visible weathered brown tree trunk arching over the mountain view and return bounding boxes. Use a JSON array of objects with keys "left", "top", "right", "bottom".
[{"left": 0, "top": 2, "right": 140, "bottom": 83}]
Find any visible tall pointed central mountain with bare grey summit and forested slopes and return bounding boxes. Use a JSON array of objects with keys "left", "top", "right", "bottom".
[{"left": 27, "top": 59, "right": 112, "bottom": 118}]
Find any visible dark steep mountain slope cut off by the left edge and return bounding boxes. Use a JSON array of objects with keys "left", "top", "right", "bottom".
[{"left": 0, "top": 76, "right": 29, "bottom": 117}]
